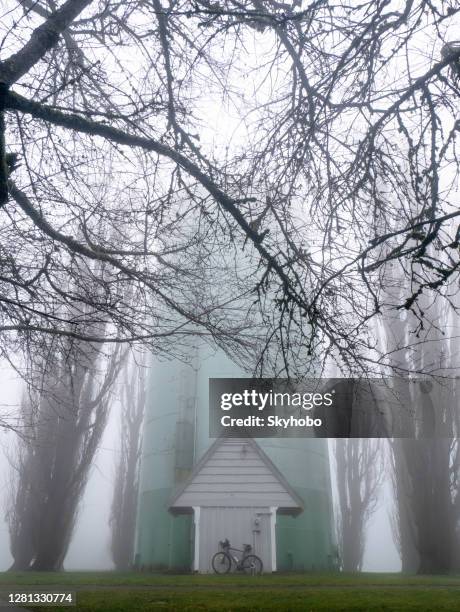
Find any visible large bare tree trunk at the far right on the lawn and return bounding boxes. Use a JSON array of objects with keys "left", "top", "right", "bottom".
[{"left": 382, "top": 262, "right": 460, "bottom": 573}]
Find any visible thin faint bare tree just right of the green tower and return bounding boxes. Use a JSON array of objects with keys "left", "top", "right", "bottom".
[{"left": 335, "top": 438, "right": 384, "bottom": 572}]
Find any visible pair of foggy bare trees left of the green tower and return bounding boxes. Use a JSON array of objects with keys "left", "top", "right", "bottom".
[{"left": 6, "top": 342, "right": 146, "bottom": 571}]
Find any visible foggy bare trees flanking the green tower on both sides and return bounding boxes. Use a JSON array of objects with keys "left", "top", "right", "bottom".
[{"left": 4, "top": 264, "right": 460, "bottom": 573}]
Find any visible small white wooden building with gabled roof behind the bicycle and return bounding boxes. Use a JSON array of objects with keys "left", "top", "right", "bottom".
[{"left": 169, "top": 438, "right": 304, "bottom": 573}]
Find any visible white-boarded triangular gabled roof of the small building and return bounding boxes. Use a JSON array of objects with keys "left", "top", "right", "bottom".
[{"left": 169, "top": 438, "right": 304, "bottom": 514}]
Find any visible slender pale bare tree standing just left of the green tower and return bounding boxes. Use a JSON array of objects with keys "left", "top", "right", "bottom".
[{"left": 110, "top": 352, "right": 147, "bottom": 571}]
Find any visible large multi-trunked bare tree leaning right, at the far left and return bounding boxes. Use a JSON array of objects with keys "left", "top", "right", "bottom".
[{"left": 7, "top": 318, "right": 123, "bottom": 571}]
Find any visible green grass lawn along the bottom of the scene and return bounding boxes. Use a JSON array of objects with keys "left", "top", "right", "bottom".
[{"left": 0, "top": 572, "right": 460, "bottom": 612}]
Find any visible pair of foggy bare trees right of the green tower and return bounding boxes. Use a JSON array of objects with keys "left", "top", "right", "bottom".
[{"left": 336, "top": 278, "right": 460, "bottom": 574}]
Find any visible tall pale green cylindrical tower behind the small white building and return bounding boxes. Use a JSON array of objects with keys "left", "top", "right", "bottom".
[{"left": 135, "top": 344, "right": 336, "bottom": 571}]
